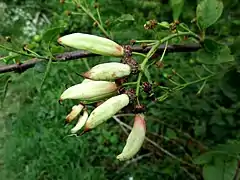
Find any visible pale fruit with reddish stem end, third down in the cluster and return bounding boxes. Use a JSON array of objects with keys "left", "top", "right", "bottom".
[{"left": 60, "top": 81, "right": 117, "bottom": 101}]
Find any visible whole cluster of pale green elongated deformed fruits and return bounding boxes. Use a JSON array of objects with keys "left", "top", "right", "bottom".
[{"left": 58, "top": 33, "right": 146, "bottom": 160}]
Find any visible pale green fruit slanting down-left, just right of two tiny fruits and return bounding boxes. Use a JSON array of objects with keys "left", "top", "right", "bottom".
[{"left": 84, "top": 94, "right": 129, "bottom": 131}]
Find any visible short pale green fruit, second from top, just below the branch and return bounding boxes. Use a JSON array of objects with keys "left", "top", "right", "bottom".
[{"left": 83, "top": 62, "right": 131, "bottom": 81}]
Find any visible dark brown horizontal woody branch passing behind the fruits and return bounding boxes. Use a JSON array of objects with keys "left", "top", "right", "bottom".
[{"left": 0, "top": 44, "right": 201, "bottom": 73}]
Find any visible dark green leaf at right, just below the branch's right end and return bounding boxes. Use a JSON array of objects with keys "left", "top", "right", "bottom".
[{"left": 197, "top": 39, "right": 234, "bottom": 64}]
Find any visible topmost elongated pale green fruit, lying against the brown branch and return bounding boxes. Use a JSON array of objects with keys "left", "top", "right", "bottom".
[{"left": 58, "top": 33, "right": 124, "bottom": 56}]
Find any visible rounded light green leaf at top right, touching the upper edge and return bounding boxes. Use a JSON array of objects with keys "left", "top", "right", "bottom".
[{"left": 196, "top": 0, "right": 223, "bottom": 29}]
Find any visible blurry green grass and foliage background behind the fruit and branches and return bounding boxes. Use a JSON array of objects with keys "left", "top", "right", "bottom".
[{"left": 0, "top": 0, "right": 240, "bottom": 180}]
